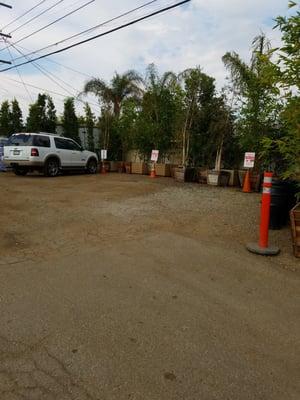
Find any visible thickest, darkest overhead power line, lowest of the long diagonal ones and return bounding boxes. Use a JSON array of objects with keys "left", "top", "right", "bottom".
[{"left": 0, "top": 0, "right": 191, "bottom": 72}]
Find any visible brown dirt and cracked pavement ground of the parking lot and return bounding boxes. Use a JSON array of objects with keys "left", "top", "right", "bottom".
[{"left": 0, "top": 173, "right": 300, "bottom": 400}]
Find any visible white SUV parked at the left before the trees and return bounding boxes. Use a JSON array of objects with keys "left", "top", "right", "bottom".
[{"left": 3, "top": 132, "right": 98, "bottom": 176}]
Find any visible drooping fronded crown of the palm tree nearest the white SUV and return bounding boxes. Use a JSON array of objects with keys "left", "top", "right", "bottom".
[{"left": 83, "top": 70, "right": 142, "bottom": 118}]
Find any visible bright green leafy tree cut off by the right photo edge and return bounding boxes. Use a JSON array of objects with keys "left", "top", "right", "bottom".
[{"left": 262, "top": 1, "right": 300, "bottom": 181}]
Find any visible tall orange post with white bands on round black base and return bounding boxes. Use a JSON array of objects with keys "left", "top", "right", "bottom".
[{"left": 246, "top": 172, "right": 280, "bottom": 256}]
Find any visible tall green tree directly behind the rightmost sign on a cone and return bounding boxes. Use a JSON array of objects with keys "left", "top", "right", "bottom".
[{"left": 223, "top": 34, "right": 281, "bottom": 152}]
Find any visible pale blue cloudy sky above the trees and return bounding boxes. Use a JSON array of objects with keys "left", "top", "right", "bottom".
[{"left": 0, "top": 0, "right": 287, "bottom": 117}]
